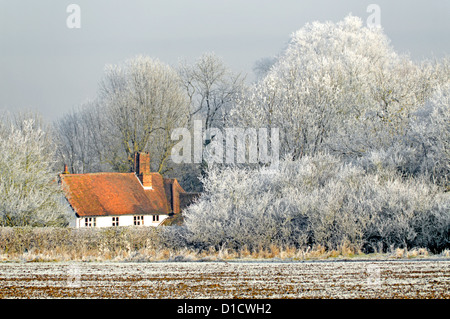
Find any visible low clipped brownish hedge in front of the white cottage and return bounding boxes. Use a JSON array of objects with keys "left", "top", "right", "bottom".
[{"left": 0, "top": 226, "right": 162, "bottom": 260}]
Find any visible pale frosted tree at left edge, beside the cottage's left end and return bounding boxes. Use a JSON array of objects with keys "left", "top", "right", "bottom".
[{"left": 0, "top": 119, "right": 68, "bottom": 226}]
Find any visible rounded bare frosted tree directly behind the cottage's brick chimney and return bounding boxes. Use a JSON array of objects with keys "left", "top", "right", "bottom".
[{"left": 99, "top": 56, "right": 189, "bottom": 173}]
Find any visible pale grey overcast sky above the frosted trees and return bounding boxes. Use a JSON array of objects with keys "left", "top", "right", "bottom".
[{"left": 0, "top": 0, "right": 450, "bottom": 120}]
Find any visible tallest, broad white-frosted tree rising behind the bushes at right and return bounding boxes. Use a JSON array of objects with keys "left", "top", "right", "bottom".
[{"left": 230, "top": 16, "right": 444, "bottom": 158}]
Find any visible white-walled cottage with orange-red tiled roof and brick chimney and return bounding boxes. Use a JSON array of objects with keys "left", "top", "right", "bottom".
[{"left": 60, "top": 153, "right": 198, "bottom": 228}]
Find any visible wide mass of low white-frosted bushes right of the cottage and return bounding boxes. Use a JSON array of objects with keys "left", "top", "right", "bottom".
[{"left": 183, "top": 154, "right": 450, "bottom": 251}]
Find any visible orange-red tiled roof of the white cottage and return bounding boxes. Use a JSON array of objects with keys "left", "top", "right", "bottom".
[{"left": 60, "top": 173, "right": 171, "bottom": 217}]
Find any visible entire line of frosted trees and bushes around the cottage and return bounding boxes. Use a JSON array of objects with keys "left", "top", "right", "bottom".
[{"left": 0, "top": 16, "right": 450, "bottom": 252}]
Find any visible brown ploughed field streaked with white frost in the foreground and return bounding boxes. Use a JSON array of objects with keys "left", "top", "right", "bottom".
[{"left": 0, "top": 259, "right": 450, "bottom": 298}]
